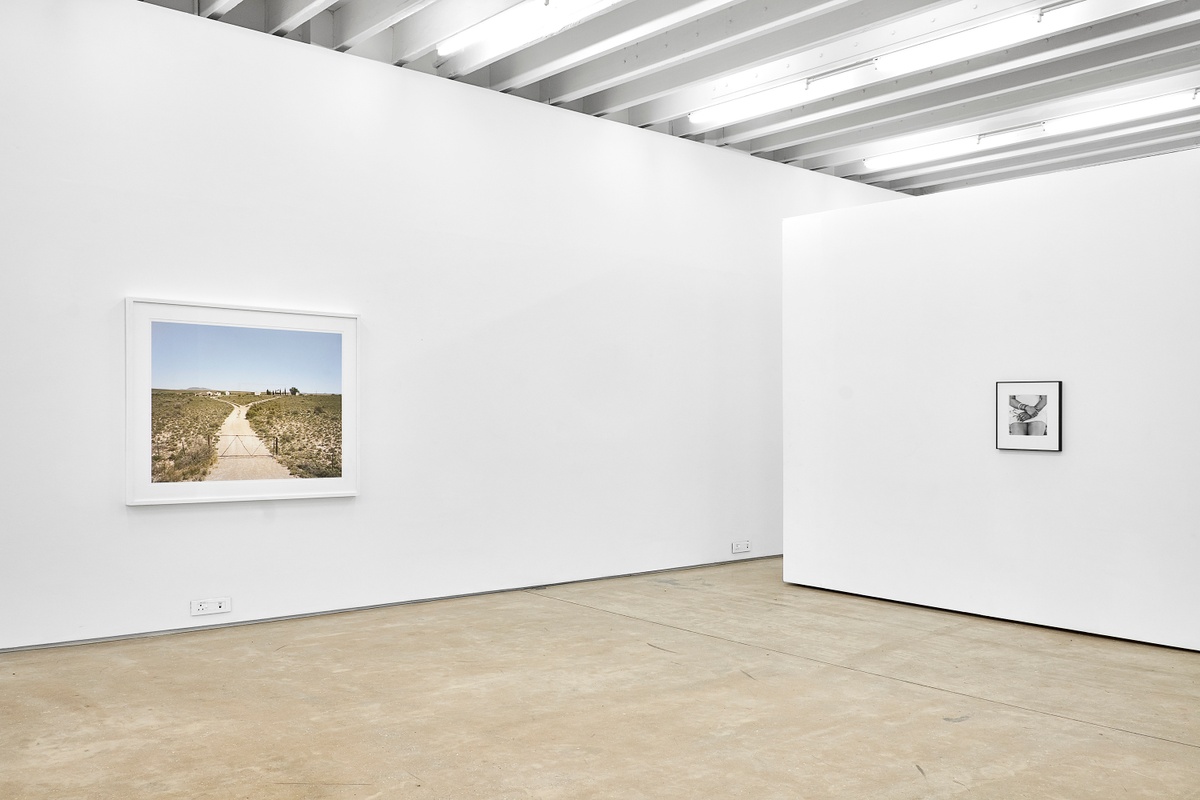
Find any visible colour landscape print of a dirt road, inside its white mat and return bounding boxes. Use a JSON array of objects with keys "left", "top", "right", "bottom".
[{"left": 150, "top": 321, "right": 342, "bottom": 483}]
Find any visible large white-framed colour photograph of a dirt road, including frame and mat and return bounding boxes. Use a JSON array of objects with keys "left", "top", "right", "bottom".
[{"left": 125, "top": 297, "right": 358, "bottom": 505}]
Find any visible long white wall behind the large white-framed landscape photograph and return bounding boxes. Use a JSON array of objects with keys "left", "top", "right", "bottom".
[{"left": 0, "top": 0, "right": 893, "bottom": 648}]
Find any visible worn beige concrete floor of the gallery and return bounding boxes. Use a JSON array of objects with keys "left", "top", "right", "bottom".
[{"left": 0, "top": 559, "right": 1200, "bottom": 800}]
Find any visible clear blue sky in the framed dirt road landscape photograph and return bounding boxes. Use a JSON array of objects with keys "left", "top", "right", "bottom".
[{"left": 150, "top": 323, "right": 342, "bottom": 395}]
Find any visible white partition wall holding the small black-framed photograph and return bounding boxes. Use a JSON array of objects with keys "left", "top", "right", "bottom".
[{"left": 784, "top": 150, "right": 1200, "bottom": 649}]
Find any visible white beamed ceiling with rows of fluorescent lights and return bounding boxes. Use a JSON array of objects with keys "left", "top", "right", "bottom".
[{"left": 145, "top": 0, "right": 1200, "bottom": 194}]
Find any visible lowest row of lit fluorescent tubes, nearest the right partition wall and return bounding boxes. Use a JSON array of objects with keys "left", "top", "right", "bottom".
[{"left": 863, "top": 89, "right": 1200, "bottom": 172}]
